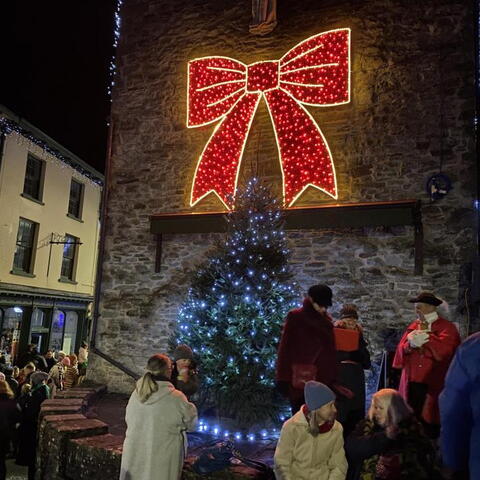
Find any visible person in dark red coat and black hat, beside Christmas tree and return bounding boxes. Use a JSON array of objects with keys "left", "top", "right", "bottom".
[{"left": 276, "top": 285, "right": 337, "bottom": 414}]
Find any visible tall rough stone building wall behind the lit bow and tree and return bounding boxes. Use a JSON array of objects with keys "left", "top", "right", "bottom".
[{"left": 92, "top": 0, "right": 475, "bottom": 391}]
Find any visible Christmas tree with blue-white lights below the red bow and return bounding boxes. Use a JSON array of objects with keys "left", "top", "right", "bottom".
[{"left": 175, "top": 179, "right": 298, "bottom": 427}]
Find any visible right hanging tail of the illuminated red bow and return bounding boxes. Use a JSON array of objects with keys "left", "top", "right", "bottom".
[{"left": 264, "top": 88, "right": 337, "bottom": 207}]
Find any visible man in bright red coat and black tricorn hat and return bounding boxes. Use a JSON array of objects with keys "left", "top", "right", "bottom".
[{"left": 393, "top": 292, "right": 460, "bottom": 436}]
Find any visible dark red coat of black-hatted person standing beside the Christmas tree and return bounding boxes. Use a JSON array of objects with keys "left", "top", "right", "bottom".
[{"left": 276, "top": 299, "right": 337, "bottom": 401}]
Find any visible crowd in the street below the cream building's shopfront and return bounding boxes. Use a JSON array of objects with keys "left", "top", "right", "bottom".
[{"left": 0, "top": 342, "right": 88, "bottom": 480}]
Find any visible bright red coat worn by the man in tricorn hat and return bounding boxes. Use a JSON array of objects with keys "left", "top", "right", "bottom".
[{"left": 393, "top": 317, "right": 460, "bottom": 424}]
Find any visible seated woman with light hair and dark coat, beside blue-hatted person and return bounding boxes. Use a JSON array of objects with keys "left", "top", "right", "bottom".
[{"left": 345, "top": 388, "right": 441, "bottom": 480}]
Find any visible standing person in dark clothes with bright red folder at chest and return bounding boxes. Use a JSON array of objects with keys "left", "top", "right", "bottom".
[{"left": 334, "top": 304, "right": 371, "bottom": 437}]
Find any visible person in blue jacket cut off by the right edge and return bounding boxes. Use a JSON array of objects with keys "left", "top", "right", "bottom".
[{"left": 440, "top": 332, "right": 480, "bottom": 479}]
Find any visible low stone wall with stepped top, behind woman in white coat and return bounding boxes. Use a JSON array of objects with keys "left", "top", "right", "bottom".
[{"left": 36, "top": 386, "right": 272, "bottom": 480}]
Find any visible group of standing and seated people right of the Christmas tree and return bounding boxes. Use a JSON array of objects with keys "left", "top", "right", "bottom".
[{"left": 274, "top": 285, "right": 474, "bottom": 480}]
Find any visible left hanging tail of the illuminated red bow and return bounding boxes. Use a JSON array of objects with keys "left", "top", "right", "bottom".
[{"left": 190, "top": 93, "right": 261, "bottom": 210}]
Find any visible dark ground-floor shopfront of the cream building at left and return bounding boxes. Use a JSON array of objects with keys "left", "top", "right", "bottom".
[{"left": 0, "top": 287, "right": 92, "bottom": 364}]
